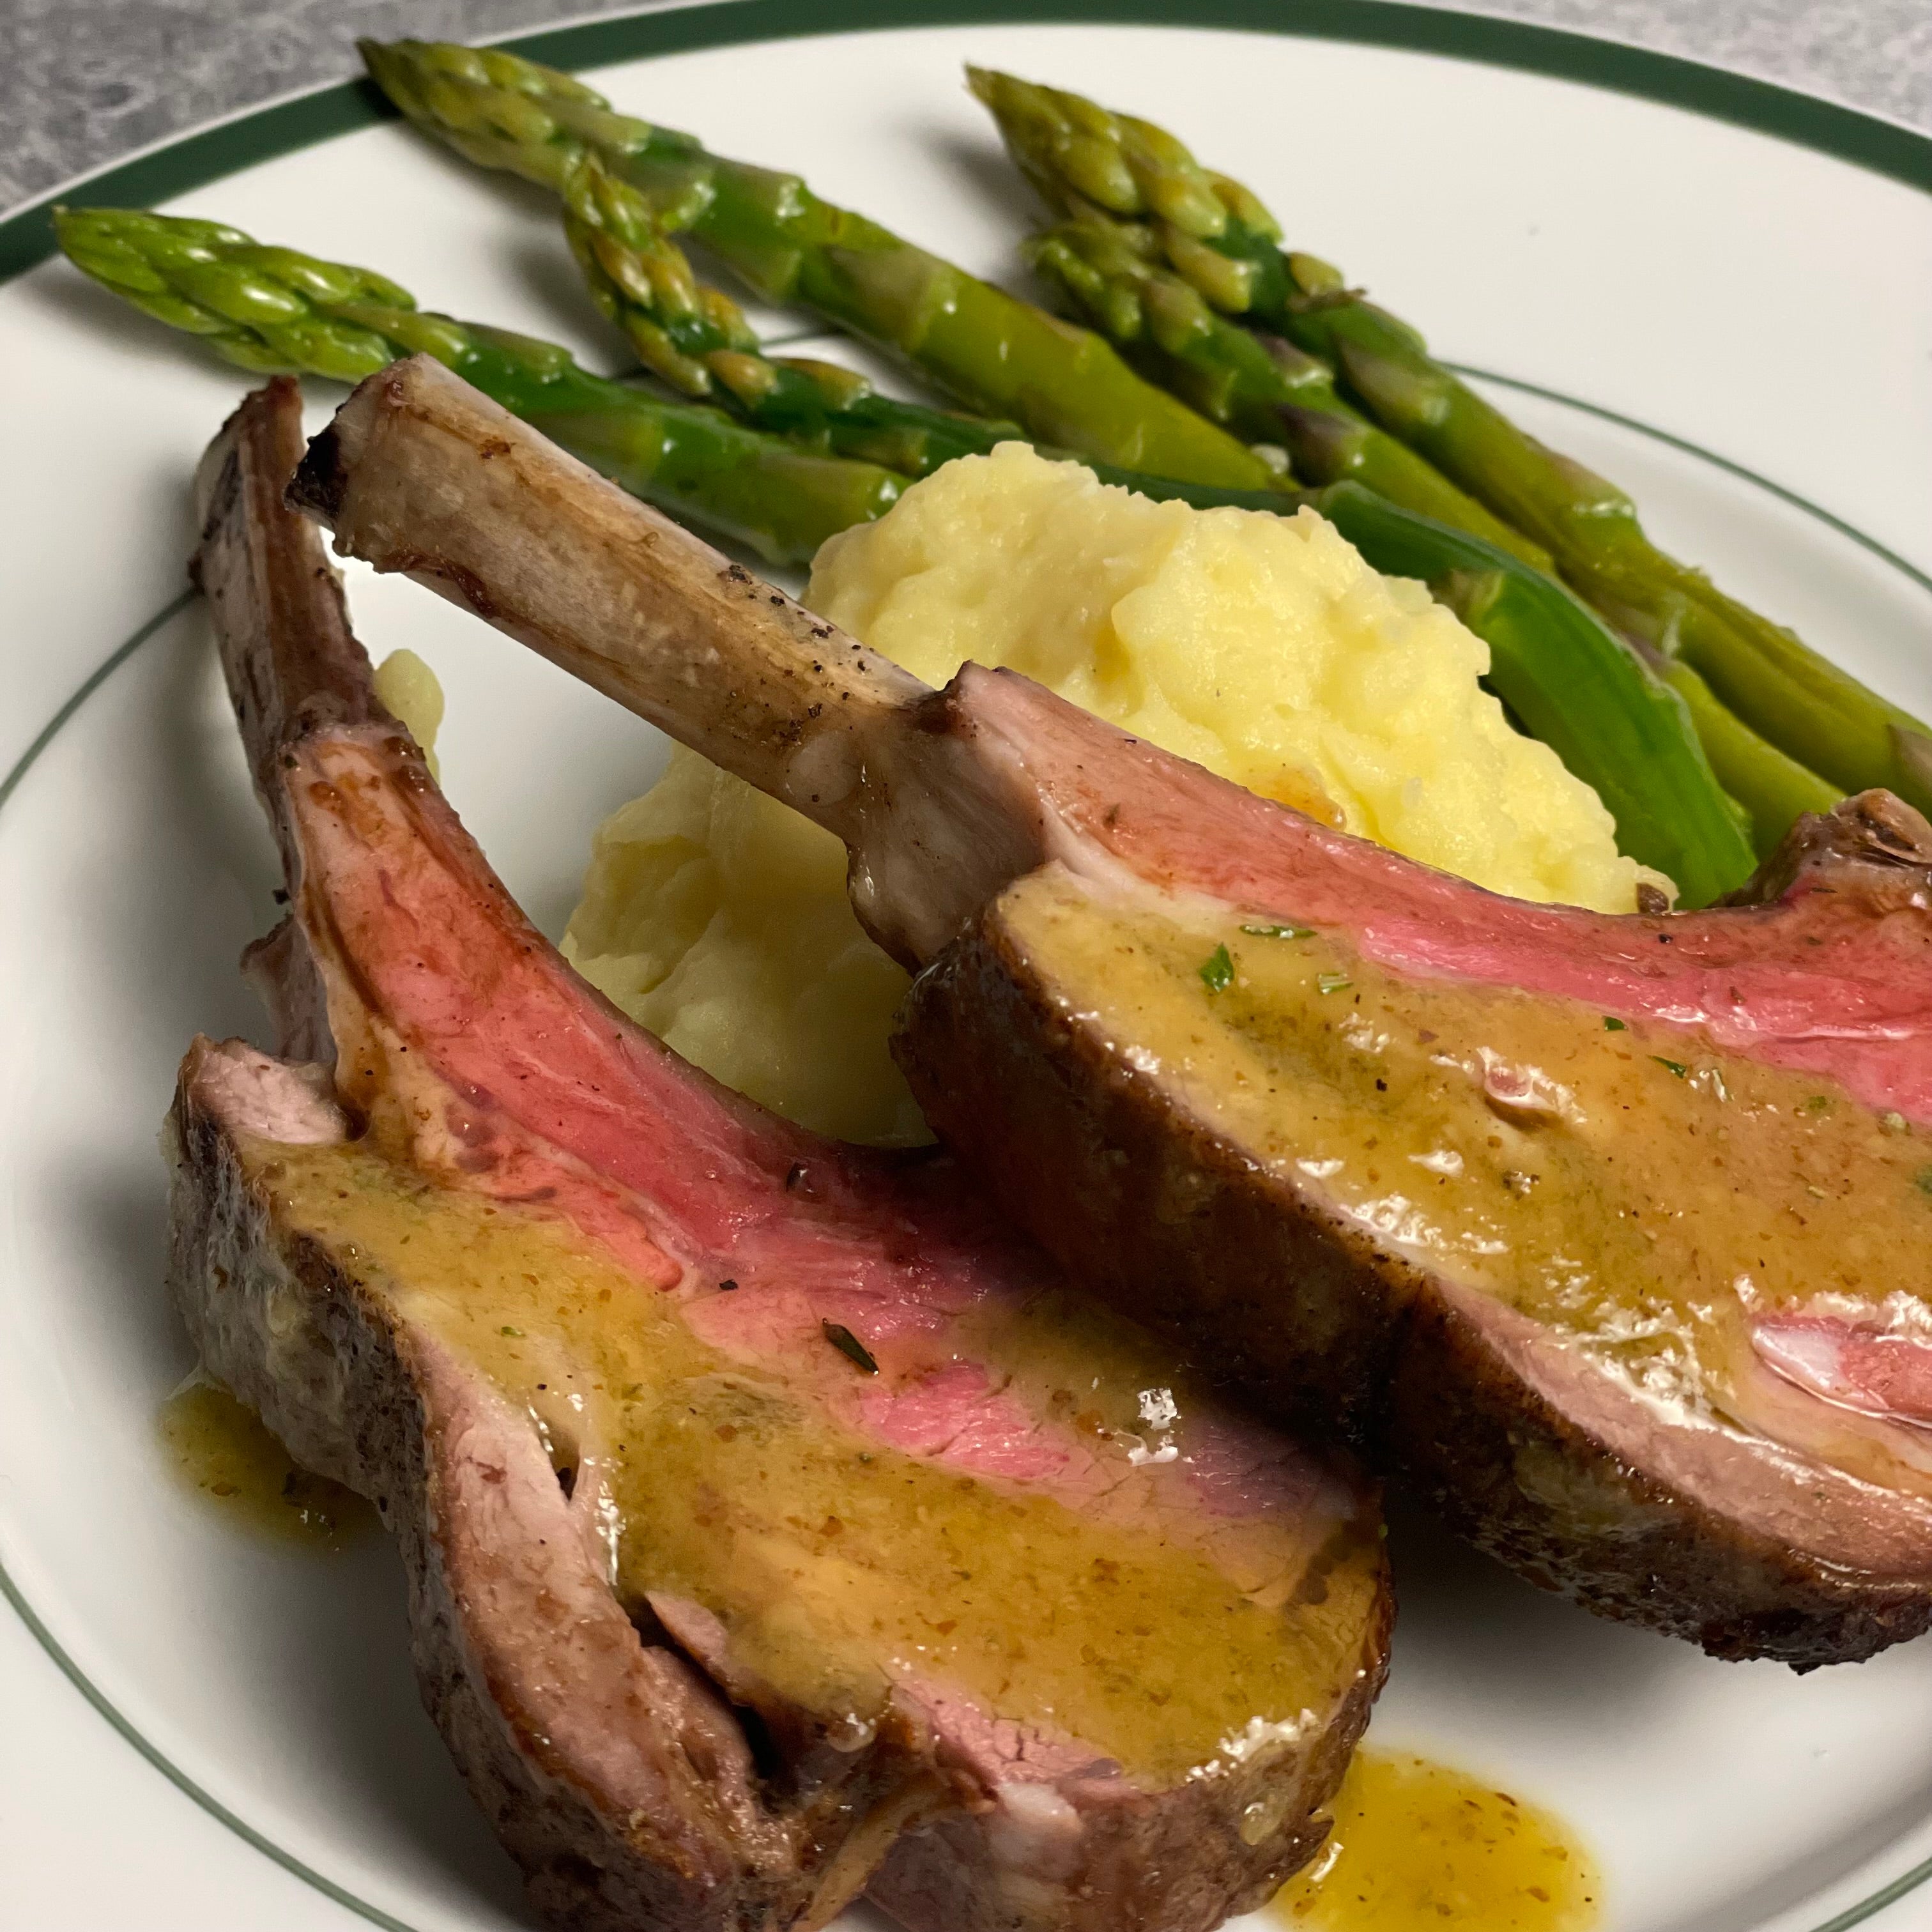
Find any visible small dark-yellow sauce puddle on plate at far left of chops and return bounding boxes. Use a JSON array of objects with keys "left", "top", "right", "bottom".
[{"left": 160, "top": 1377, "right": 377, "bottom": 1549}]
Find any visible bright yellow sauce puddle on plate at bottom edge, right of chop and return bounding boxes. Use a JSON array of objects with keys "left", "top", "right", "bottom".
[{"left": 1273, "top": 1751, "right": 1604, "bottom": 1932}]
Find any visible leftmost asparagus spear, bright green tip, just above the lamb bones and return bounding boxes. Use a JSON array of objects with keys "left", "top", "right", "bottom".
[{"left": 54, "top": 209, "right": 904, "bottom": 562}]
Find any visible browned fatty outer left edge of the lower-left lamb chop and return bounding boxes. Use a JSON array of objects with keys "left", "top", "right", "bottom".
[{"left": 168, "top": 1039, "right": 904, "bottom": 1932}]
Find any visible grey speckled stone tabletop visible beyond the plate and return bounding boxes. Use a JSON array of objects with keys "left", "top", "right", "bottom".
[{"left": 0, "top": 0, "right": 1932, "bottom": 211}]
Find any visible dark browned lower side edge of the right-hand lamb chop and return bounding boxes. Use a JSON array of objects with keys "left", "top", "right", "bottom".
[{"left": 894, "top": 884, "right": 1932, "bottom": 1669}]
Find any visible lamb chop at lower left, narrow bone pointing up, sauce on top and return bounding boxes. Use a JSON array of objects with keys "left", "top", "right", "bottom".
[{"left": 170, "top": 379, "right": 1391, "bottom": 1932}]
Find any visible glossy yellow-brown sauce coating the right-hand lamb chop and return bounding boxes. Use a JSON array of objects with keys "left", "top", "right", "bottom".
[{"left": 1000, "top": 873, "right": 1932, "bottom": 1487}]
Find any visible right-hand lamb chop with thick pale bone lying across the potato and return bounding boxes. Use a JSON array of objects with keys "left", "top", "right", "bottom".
[{"left": 292, "top": 359, "right": 1932, "bottom": 1667}]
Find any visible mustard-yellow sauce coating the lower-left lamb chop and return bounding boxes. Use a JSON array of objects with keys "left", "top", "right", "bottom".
[{"left": 229, "top": 1128, "right": 1379, "bottom": 1781}]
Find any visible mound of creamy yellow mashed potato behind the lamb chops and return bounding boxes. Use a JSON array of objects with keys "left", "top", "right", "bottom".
[{"left": 564, "top": 445, "right": 1656, "bottom": 1144}]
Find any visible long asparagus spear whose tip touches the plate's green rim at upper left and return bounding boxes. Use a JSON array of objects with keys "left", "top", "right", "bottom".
[{"left": 361, "top": 41, "right": 1275, "bottom": 489}]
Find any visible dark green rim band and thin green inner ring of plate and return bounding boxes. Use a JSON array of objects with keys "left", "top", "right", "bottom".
[{"left": 0, "top": 0, "right": 1932, "bottom": 1932}]
